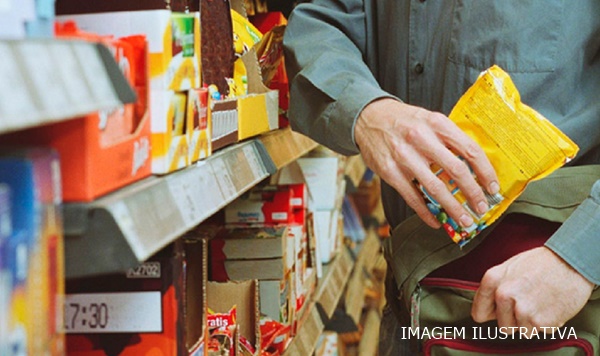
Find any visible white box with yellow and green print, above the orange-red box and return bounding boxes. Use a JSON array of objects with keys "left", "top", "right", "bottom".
[{"left": 57, "top": 10, "right": 200, "bottom": 91}]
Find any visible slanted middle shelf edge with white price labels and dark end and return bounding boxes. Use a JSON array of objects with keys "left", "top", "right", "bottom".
[{"left": 64, "top": 140, "right": 274, "bottom": 277}]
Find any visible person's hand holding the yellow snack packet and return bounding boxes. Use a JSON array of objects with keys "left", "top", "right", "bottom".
[{"left": 354, "top": 99, "right": 499, "bottom": 228}]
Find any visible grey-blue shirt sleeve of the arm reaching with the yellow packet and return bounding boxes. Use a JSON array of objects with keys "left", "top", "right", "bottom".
[{"left": 284, "top": 0, "right": 390, "bottom": 155}]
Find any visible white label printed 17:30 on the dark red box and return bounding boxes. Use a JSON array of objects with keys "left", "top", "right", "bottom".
[{"left": 65, "top": 292, "right": 162, "bottom": 334}]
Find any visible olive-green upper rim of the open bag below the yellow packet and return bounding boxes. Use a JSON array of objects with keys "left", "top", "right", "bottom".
[{"left": 383, "top": 165, "right": 600, "bottom": 303}]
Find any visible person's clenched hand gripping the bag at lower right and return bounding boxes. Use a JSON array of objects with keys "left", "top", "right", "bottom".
[{"left": 471, "top": 247, "right": 593, "bottom": 332}]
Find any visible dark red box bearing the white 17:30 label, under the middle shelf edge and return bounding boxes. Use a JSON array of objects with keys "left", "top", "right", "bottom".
[{"left": 65, "top": 239, "right": 206, "bottom": 356}]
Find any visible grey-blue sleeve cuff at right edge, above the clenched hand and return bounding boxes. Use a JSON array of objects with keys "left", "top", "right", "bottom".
[{"left": 546, "top": 181, "right": 600, "bottom": 284}]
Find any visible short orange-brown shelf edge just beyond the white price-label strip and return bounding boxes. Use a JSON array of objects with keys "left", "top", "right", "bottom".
[{"left": 259, "top": 127, "right": 318, "bottom": 169}]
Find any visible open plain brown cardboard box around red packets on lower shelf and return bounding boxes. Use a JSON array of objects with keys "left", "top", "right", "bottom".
[{"left": 206, "top": 280, "right": 260, "bottom": 349}]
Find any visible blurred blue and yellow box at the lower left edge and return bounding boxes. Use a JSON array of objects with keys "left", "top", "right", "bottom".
[{"left": 0, "top": 148, "right": 64, "bottom": 355}]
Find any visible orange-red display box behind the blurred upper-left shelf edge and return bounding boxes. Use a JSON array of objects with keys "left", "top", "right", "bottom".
[{"left": 3, "top": 22, "right": 151, "bottom": 202}]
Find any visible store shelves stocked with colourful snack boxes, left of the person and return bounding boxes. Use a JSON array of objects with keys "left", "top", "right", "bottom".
[{"left": 0, "top": 0, "right": 379, "bottom": 356}]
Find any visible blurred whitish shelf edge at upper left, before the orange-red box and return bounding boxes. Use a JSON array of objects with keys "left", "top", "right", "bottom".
[{"left": 0, "top": 40, "right": 136, "bottom": 133}]
